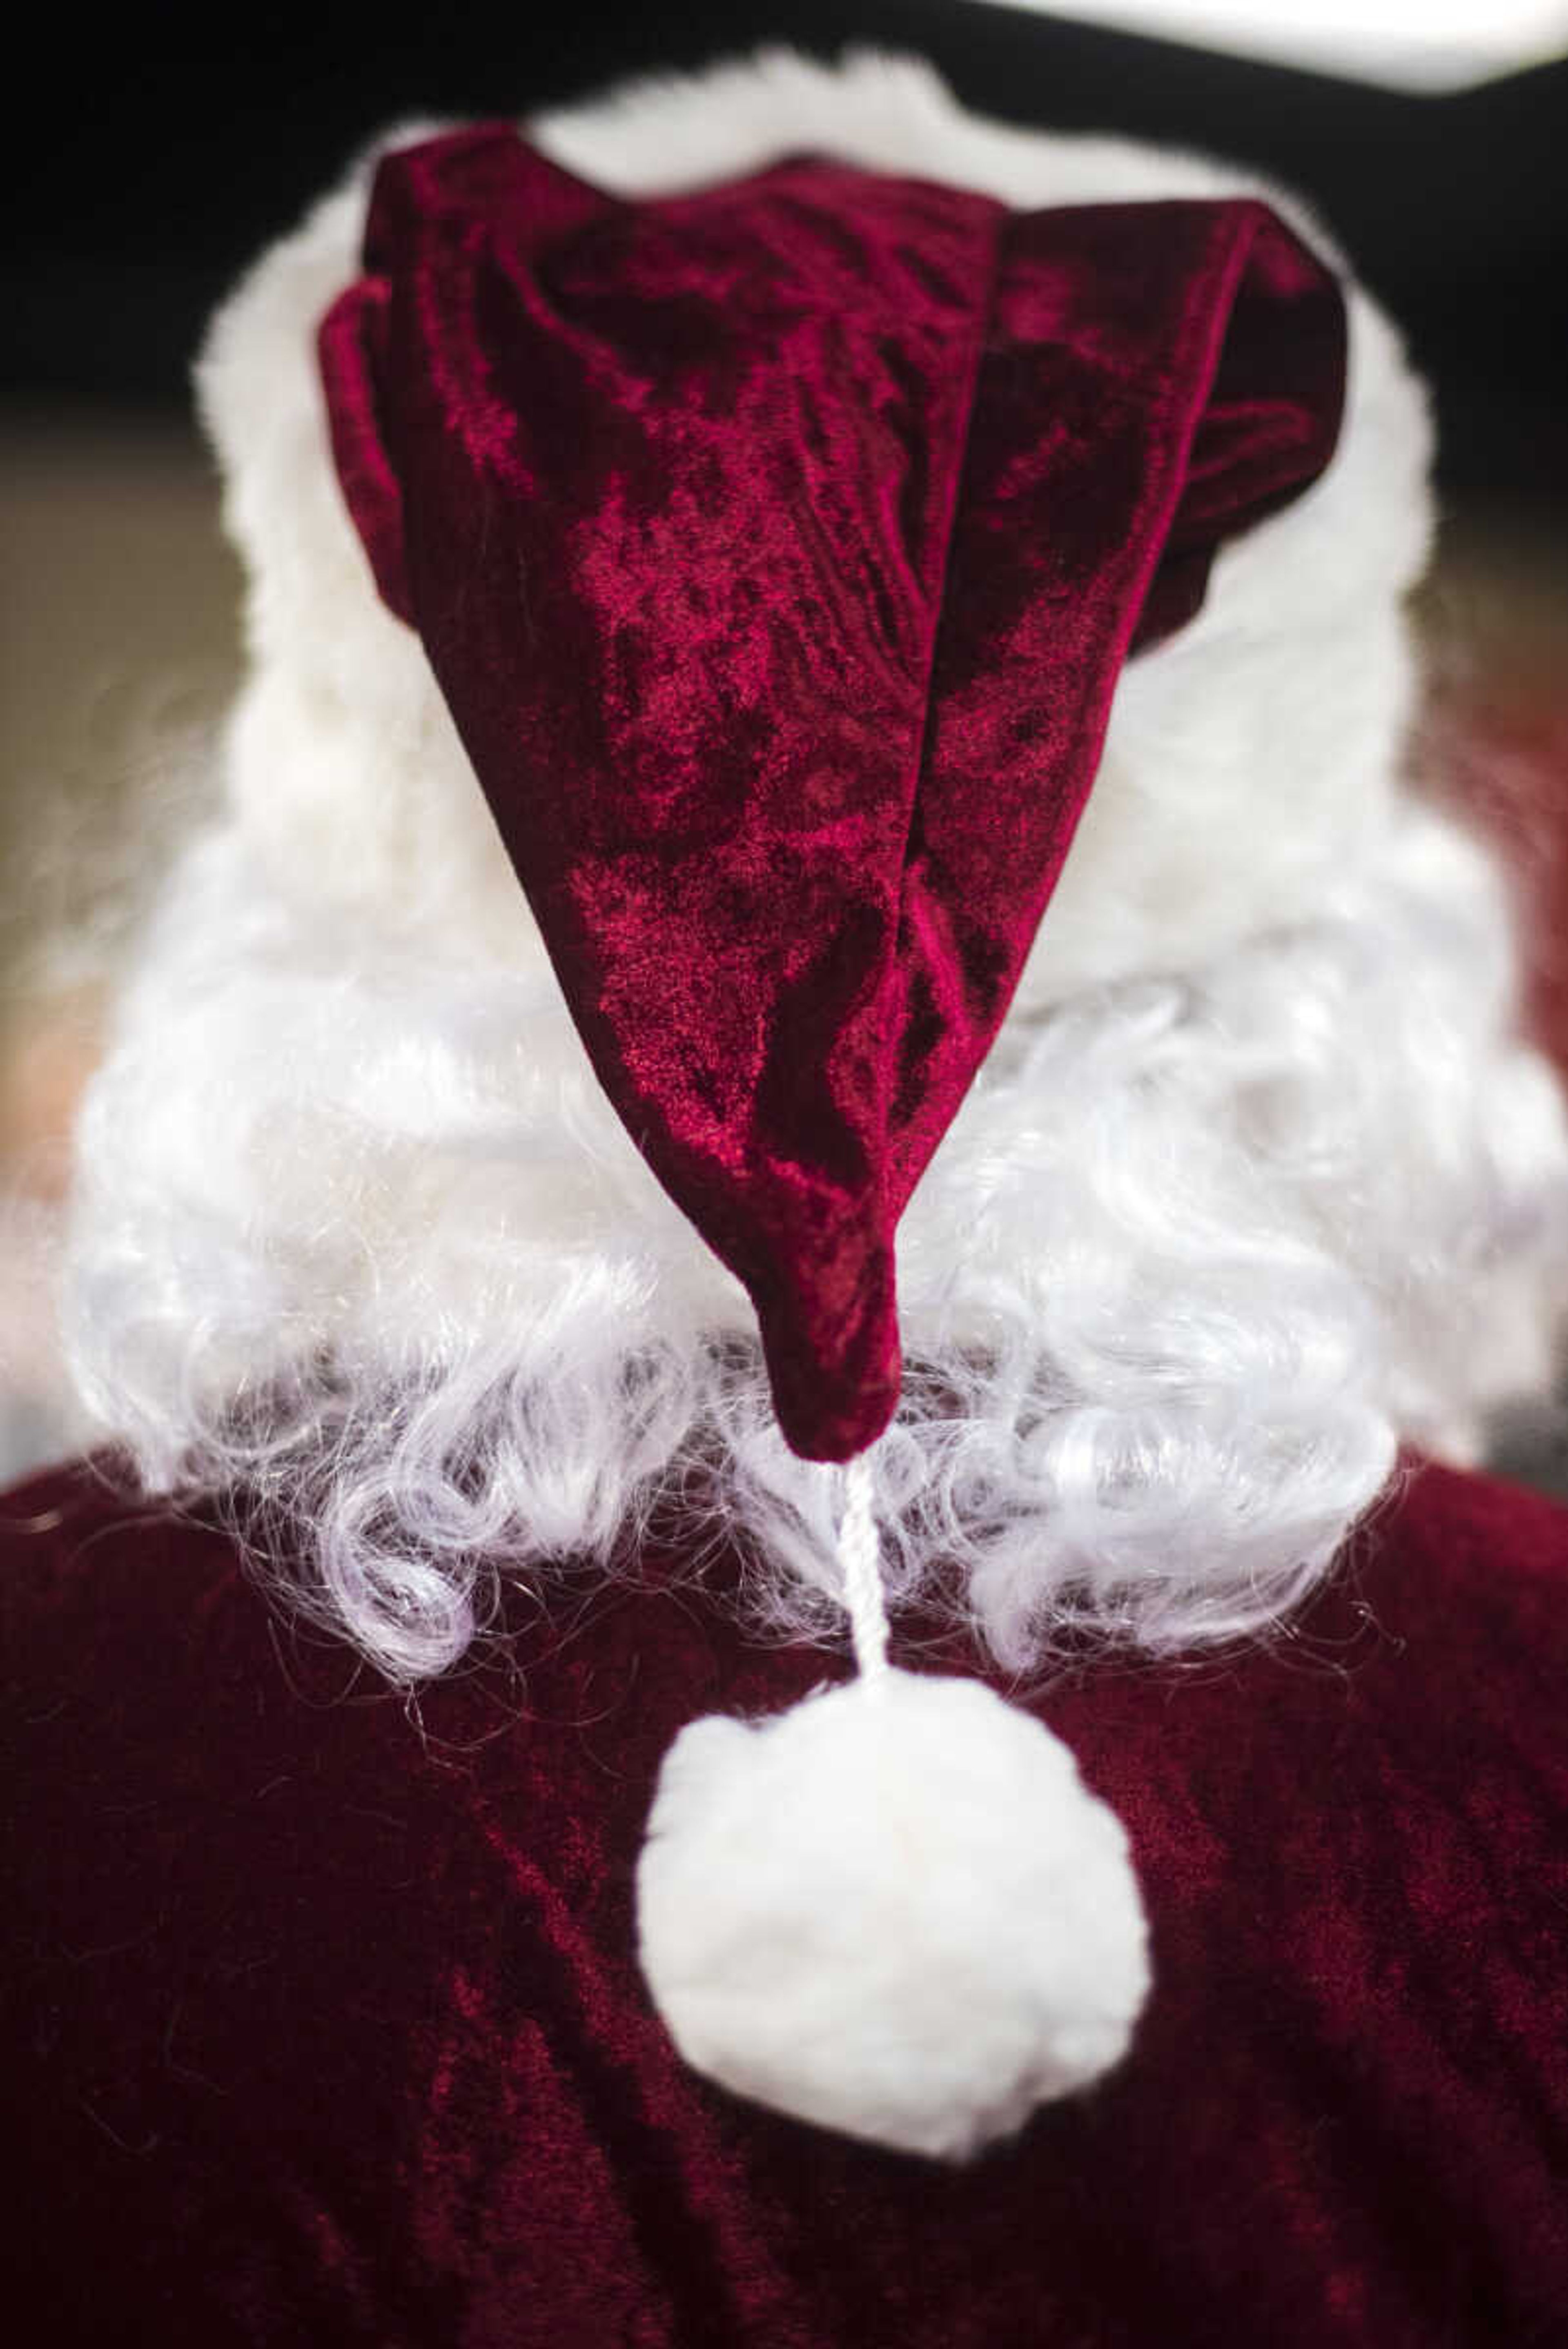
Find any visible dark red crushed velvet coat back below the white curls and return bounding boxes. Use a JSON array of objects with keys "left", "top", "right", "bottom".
[{"left": 0, "top": 1468, "right": 1568, "bottom": 2349}]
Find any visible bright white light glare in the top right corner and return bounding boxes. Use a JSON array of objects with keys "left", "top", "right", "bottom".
[{"left": 973, "top": 0, "right": 1568, "bottom": 89}]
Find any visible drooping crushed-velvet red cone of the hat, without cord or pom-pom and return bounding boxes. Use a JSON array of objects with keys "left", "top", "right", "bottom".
[{"left": 320, "top": 125, "right": 1345, "bottom": 1459}]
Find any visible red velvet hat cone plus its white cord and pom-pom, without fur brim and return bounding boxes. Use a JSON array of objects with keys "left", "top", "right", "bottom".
[{"left": 320, "top": 125, "right": 1345, "bottom": 2154}]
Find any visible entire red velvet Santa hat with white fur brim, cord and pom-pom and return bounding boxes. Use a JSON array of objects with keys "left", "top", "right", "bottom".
[{"left": 181, "top": 61, "right": 1457, "bottom": 2154}]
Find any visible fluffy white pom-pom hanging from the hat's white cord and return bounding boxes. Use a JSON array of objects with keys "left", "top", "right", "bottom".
[{"left": 637, "top": 1670, "right": 1149, "bottom": 2159}]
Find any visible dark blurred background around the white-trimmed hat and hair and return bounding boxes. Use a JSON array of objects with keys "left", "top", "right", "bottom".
[{"left": 0, "top": 0, "right": 1568, "bottom": 1470}]
